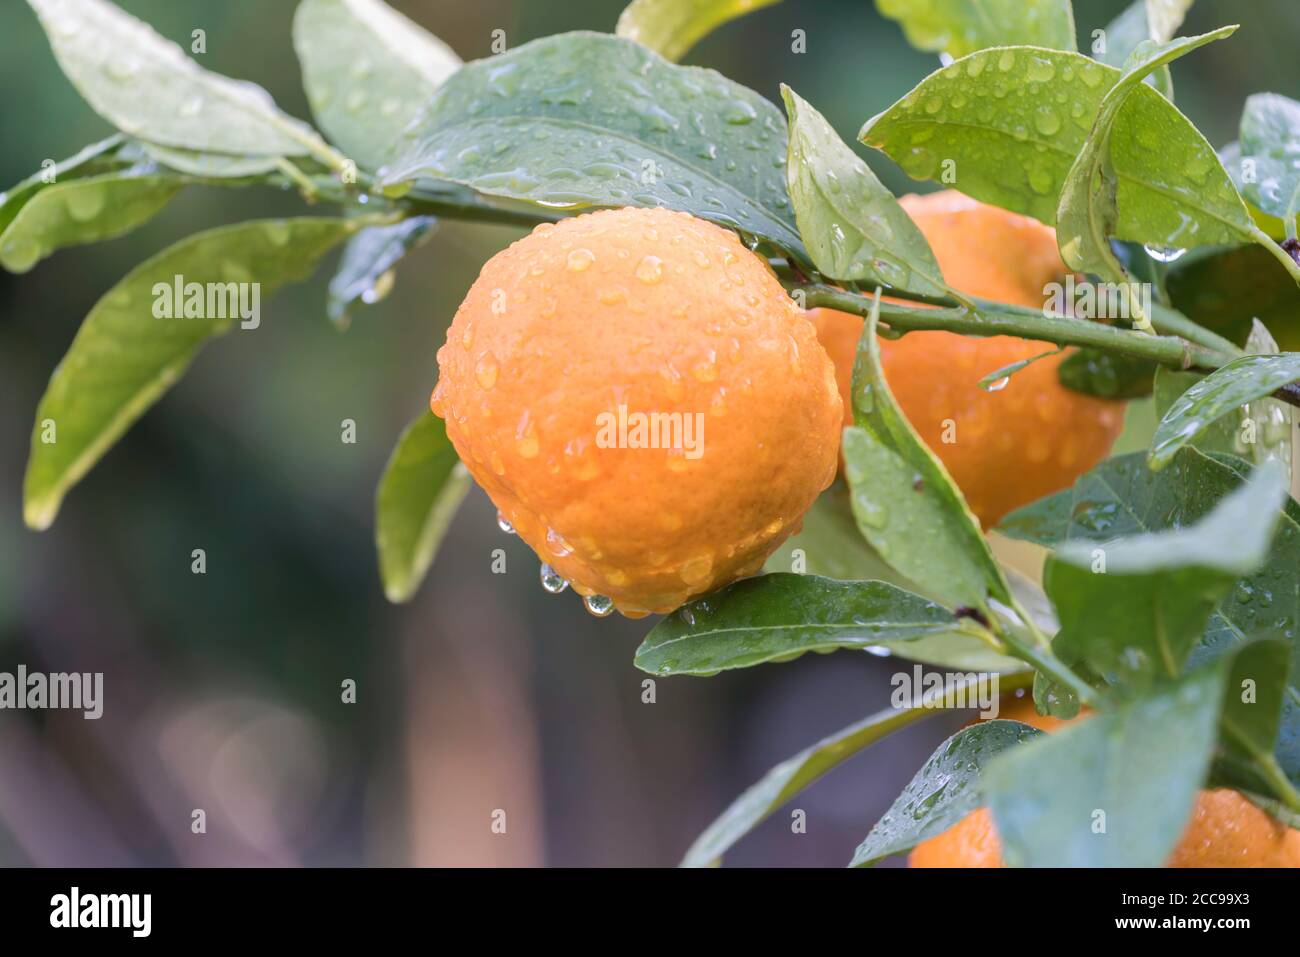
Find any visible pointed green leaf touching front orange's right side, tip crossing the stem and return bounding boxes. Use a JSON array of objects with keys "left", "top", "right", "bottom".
[{"left": 842, "top": 299, "right": 1011, "bottom": 609}]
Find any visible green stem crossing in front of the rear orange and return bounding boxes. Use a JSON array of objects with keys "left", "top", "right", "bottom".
[{"left": 794, "top": 283, "right": 1239, "bottom": 369}]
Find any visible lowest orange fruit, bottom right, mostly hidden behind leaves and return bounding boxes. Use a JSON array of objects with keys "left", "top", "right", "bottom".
[{"left": 907, "top": 697, "right": 1300, "bottom": 867}]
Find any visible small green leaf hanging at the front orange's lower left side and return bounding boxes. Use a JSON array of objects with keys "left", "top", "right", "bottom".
[{"left": 374, "top": 412, "right": 471, "bottom": 602}]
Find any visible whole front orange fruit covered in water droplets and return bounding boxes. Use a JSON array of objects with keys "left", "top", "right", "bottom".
[{"left": 430, "top": 208, "right": 842, "bottom": 616}]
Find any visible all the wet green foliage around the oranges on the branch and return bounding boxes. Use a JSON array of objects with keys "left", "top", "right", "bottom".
[{"left": 0, "top": 0, "right": 1300, "bottom": 865}]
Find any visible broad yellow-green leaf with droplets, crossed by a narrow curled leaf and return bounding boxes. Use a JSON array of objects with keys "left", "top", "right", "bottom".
[{"left": 861, "top": 47, "right": 1255, "bottom": 237}]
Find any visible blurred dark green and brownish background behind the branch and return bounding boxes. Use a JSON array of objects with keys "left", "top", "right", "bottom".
[{"left": 0, "top": 0, "right": 1300, "bottom": 865}]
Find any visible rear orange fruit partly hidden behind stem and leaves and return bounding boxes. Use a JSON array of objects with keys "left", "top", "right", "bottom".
[{"left": 810, "top": 191, "right": 1123, "bottom": 528}]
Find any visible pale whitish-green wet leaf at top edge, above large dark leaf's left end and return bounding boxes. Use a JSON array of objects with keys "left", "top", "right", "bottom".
[{"left": 294, "top": 0, "right": 460, "bottom": 169}]
